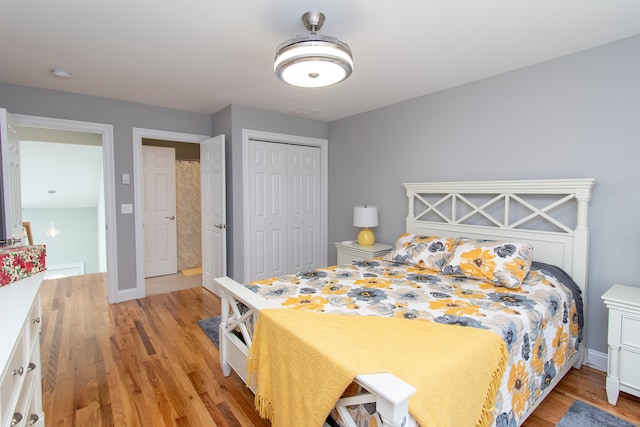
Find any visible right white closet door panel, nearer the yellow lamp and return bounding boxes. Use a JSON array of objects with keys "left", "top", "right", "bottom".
[{"left": 287, "top": 145, "right": 322, "bottom": 272}]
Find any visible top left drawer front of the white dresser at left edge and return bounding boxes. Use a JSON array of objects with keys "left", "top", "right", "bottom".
[{"left": 0, "top": 322, "right": 27, "bottom": 425}]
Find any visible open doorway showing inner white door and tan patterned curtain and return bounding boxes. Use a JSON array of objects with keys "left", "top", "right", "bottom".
[{"left": 142, "top": 138, "right": 202, "bottom": 296}]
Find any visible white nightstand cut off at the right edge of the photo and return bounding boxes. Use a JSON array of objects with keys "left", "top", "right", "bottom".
[{"left": 602, "top": 285, "right": 640, "bottom": 405}]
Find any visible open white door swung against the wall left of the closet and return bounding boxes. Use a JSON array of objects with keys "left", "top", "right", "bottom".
[{"left": 200, "top": 135, "right": 227, "bottom": 296}]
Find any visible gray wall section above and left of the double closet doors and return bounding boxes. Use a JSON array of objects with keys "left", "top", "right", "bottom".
[{"left": 213, "top": 105, "right": 328, "bottom": 282}]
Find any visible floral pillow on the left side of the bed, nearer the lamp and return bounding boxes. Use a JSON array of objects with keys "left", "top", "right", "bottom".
[{"left": 382, "top": 233, "right": 456, "bottom": 271}]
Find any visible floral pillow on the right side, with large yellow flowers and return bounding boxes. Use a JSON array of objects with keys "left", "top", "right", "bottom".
[{"left": 442, "top": 238, "right": 533, "bottom": 288}]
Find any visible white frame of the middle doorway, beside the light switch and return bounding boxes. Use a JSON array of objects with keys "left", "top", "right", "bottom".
[{"left": 133, "top": 128, "right": 211, "bottom": 298}]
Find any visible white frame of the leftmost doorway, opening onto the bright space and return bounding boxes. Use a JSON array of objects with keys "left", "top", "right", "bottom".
[{"left": 9, "top": 112, "right": 119, "bottom": 304}]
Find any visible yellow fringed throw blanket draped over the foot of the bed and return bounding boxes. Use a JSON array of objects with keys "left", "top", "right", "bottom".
[{"left": 247, "top": 308, "right": 507, "bottom": 427}]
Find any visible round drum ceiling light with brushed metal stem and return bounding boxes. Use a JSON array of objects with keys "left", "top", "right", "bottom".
[{"left": 273, "top": 11, "right": 353, "bottom": 87}]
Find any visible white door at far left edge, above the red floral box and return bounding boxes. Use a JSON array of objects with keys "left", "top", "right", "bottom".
[{"left": 0, "top": 108, "right": 22, "bottom": 245}]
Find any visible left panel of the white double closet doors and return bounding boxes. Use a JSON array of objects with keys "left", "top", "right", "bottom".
[{"left": 245, "top": 140, "right": 289, "bottom": 280}]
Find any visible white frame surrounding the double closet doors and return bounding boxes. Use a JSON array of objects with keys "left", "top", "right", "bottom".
[{"left": 242, "top": 129, "right": 329, "bottom": 282}]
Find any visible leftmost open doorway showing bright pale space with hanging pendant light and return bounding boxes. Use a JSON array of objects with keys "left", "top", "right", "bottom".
[{"left": 18, "top": 127, "right": 107, "bottom": 279}]
